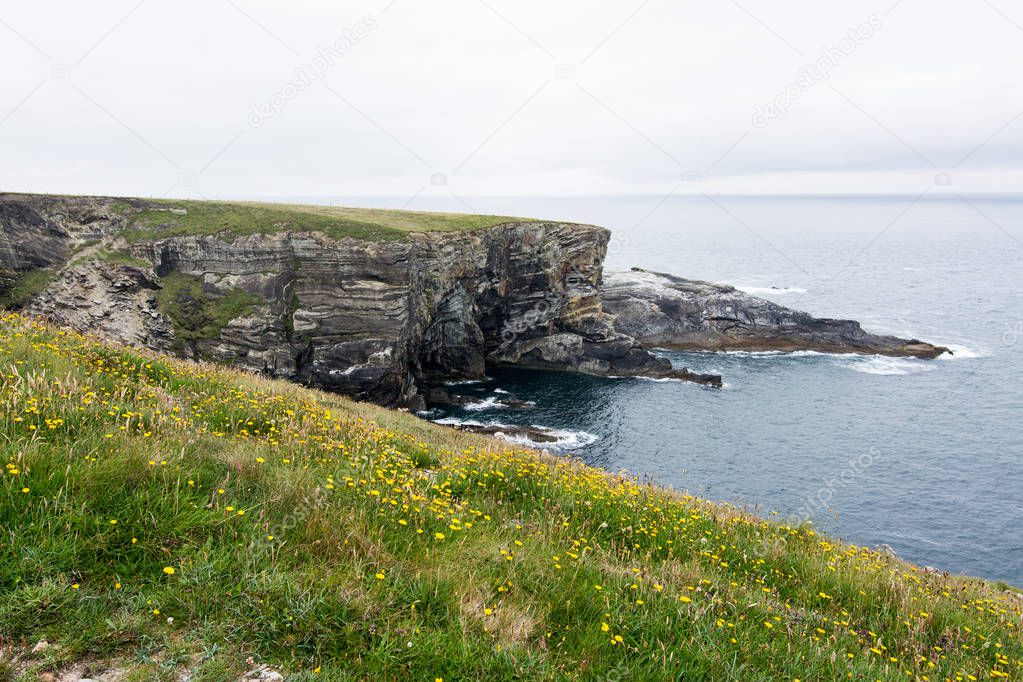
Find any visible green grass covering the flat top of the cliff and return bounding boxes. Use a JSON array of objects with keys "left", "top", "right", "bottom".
[{"left": 117, "top": 199, "right": 522, "bottom": 242}]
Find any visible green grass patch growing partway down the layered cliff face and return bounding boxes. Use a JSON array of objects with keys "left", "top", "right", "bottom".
[{"left": 157, "top": 272, "right": 260, "bottom": 355}]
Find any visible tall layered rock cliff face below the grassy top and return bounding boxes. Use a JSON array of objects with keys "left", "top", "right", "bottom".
[{"left": 0, "top": 195, "right": 720, "bottom": 407}]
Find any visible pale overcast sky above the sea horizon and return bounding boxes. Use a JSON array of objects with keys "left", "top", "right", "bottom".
[{"left": 0, "top": 0, "right": 1023, "bottom": 200}]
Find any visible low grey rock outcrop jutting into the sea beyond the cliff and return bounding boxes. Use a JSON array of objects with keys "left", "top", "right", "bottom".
[{"left": 601, "top": 268, "right": 950, "bottom": 358}]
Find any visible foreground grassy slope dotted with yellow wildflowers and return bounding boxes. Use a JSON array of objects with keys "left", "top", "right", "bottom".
[{"left": 0, "top": 315, "right": 1023, "bottom": 680}]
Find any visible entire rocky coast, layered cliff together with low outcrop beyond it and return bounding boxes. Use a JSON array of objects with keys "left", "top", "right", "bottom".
[{"left": 0, "top": 194, "right": 948, "bottom": 410}]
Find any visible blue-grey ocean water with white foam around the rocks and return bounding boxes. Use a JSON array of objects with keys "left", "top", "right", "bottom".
[{"left": 319, "top": 196, "right": 1023, "bottom": 586}]
